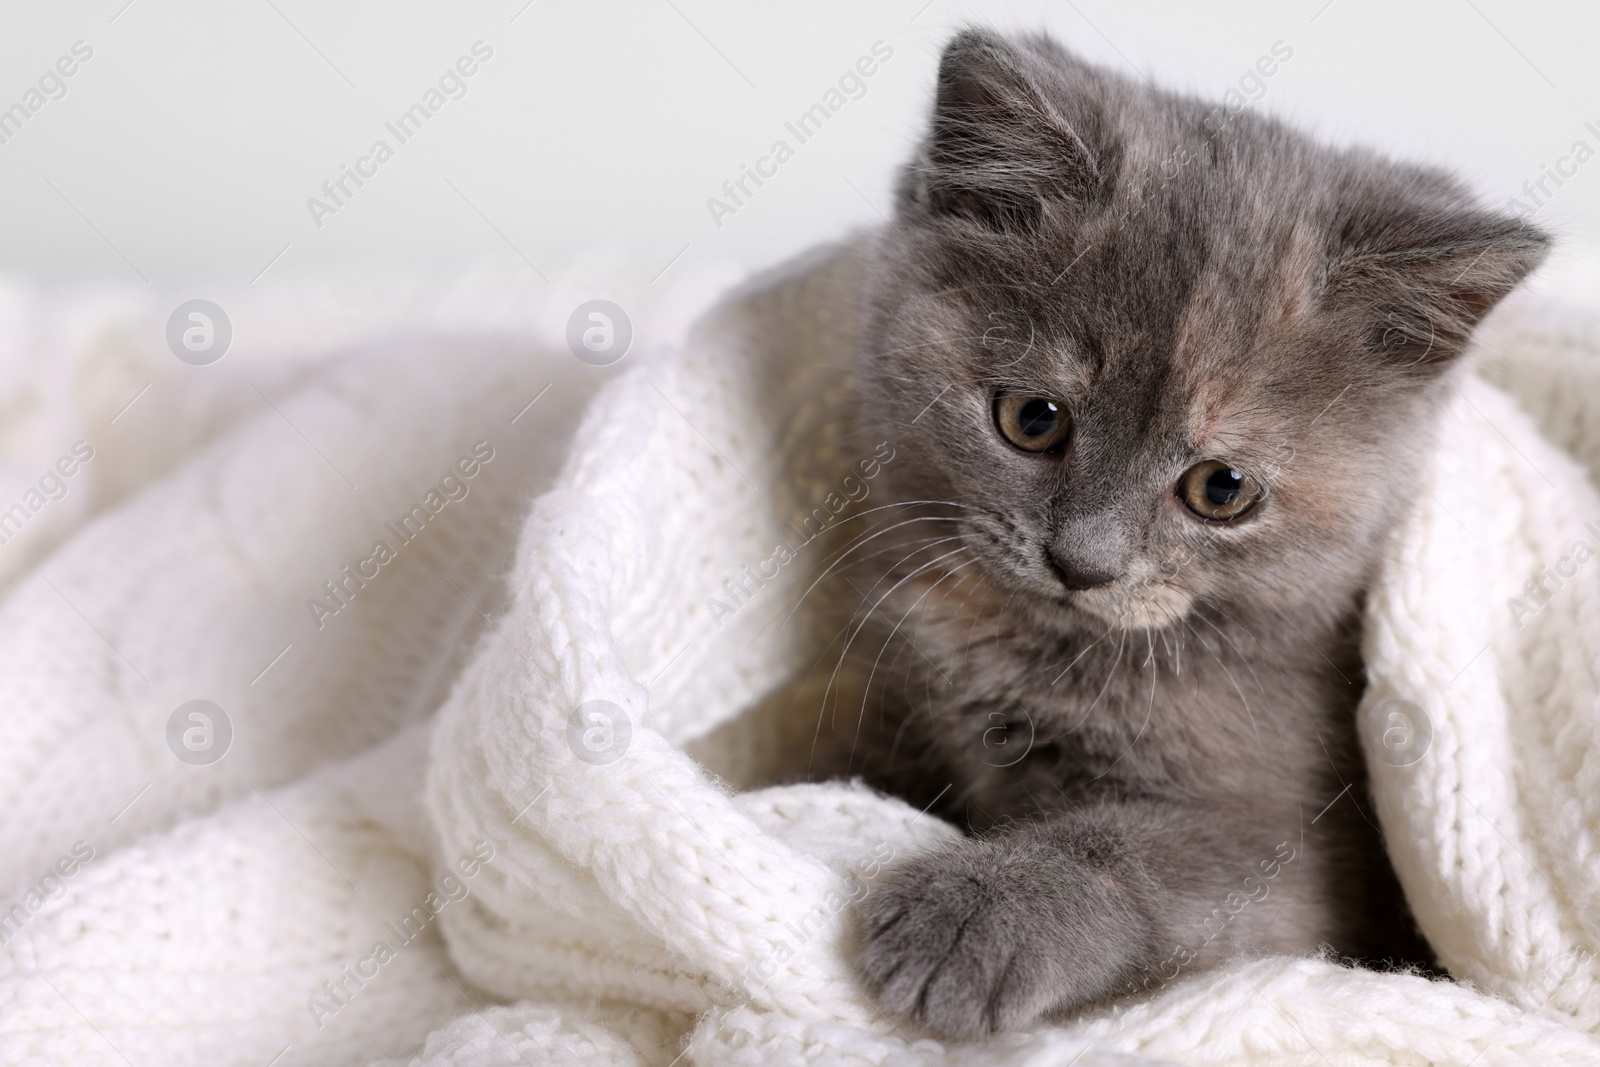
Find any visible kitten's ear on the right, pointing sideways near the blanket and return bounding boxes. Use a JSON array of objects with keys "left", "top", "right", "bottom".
[{"left": 1328, "top": 197, "right": 1550, "bottom": 368}]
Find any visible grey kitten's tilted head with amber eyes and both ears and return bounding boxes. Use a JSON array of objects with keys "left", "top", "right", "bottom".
[{"left": 861, "top": 30, "right": 1549, "bottom": 629}]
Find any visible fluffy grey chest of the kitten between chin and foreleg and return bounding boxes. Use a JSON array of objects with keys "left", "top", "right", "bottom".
[{"left": 874, "top": 585, "right": 1360, "bottom": 817}]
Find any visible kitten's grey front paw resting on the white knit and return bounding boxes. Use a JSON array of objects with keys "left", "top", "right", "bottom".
[{"left": 856, "top": 841, "right": 1074, "bottom": 1038}]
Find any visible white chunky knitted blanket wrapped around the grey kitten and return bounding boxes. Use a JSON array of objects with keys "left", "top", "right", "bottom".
[{"left": 0, "top": 241, "right": 1600, "bottom": 1067}]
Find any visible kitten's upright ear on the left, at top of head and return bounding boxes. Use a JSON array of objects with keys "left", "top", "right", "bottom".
[{"left": 920, "top": 29, "right": 1101, "bottom": 234}]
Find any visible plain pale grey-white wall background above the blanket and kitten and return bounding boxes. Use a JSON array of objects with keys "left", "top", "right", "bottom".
[{"left": 0, "top": 0, "right": 1600, "bottom": 288}]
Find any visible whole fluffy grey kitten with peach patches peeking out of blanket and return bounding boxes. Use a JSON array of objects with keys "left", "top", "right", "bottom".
[{"left": 826, "top": 30, "right": 1549, "bottom": 1037}]
